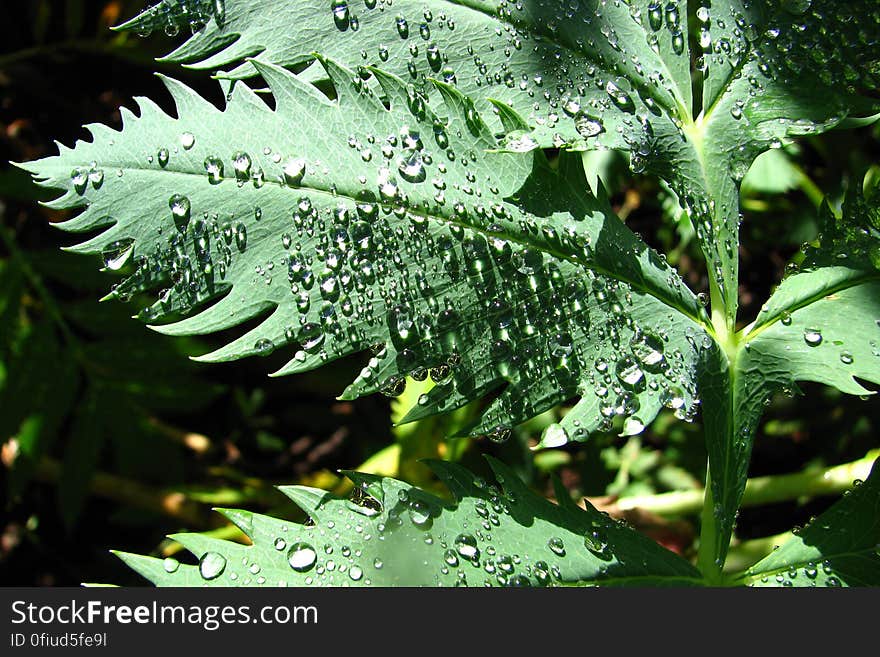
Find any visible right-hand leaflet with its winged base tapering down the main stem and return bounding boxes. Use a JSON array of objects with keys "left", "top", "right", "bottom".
[{"left": 700, "top": 190, "right": 880, "bottom": 558}]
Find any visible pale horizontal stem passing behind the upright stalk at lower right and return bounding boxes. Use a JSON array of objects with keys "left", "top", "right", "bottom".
[{"left": 617, "top": 450, "right": 880, "bottom": 516}]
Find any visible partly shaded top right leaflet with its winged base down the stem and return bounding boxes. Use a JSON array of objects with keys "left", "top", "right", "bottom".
[{"left": 692, "top": 0, "right": 880, "bottom": 328}]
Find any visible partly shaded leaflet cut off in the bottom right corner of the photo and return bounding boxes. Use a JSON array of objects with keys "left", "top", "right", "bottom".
[{"left": 734, "top": 454, "right": 880, "bottom": 587}]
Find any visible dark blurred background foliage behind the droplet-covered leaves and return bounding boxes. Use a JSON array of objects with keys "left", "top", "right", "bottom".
[{"left": 0, "top": 0, "right": 880, "bottom": 585}]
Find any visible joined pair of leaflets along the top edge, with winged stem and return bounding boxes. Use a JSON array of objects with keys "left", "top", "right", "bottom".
[{"left": 115, "top": 0, "right": 880, "bottom": 329}]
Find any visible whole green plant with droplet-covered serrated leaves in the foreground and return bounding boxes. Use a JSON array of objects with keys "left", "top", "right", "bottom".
[{"left": 13, "top": 0, "right": 880, "bottom": 586}]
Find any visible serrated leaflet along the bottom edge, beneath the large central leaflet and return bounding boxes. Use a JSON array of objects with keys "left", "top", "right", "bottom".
[{"left": 119, "top": 460, "right": 701, "bottom": 586}]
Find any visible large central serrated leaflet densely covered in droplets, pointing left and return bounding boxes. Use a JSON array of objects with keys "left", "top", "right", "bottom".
[{"left": 18, "top": 61, "right": 711, "bottom": 444}]
